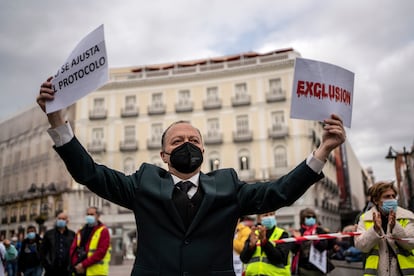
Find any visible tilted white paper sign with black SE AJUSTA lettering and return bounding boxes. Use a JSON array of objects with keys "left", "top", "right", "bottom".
[{"left": 46, "top": 25, "right": 108, "bottom": 113}]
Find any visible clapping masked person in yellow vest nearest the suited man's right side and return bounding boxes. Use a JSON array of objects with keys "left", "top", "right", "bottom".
[{"left": 240, "top": 212, "right": 290, "bottom": 276}]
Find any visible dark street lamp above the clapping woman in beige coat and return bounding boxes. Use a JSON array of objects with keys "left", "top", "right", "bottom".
[{"left": 385, "top": 146, "right": 414, "bottom": 211}]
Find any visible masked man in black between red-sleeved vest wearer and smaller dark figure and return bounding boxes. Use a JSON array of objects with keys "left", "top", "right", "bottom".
[{"left": 40, "top": 212, "right": 75, "bottom": 276}]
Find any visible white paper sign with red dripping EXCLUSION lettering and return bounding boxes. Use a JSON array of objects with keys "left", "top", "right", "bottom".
[{"left": 290, "top": 58, "right": 354, "bottom": 128}]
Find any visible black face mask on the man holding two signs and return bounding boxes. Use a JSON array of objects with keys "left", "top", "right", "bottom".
[{"left": 165, "top": 142, "right": 203, "bottom": 173}]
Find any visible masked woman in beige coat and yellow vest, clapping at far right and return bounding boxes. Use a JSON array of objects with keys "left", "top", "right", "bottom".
[{"left": 354, "top": 181, "right": 414, "bottom": 276}]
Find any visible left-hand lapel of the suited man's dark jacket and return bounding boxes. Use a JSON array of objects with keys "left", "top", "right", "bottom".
[{"left": 160, "top": 176, "right": 185, "bottom": 232}]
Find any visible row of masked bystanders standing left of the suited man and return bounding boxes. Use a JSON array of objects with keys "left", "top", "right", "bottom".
[{"left": 0, "top": 207, "right": 111, "bottom": 276}]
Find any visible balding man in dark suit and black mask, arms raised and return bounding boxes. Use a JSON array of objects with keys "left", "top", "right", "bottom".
[{"left": 37, "top": 78, "right": 345, "bottom": 276}]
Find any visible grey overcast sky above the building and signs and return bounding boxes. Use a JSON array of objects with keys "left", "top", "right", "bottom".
[{"left": 0, "top": 0, "right": 414, "bottom": 180}]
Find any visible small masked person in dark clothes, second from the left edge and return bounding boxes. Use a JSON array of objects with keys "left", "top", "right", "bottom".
[{"left": 17, "top": 225, "right": 43, "bottom": 276}]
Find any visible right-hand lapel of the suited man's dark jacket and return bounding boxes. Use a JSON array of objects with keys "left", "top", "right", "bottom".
[{"left": 187, "top": 173, "right": 217, "bottom": 235}]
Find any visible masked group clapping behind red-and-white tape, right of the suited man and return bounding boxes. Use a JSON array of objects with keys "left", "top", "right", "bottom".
[{"left": 233, "top": 181, "right": 414, "bottom": 276}]
